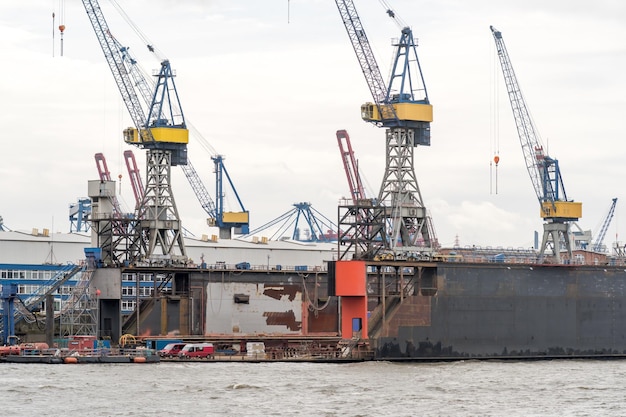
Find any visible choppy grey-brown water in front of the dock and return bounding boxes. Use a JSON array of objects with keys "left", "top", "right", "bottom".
[{"left": 0, "top": 360, "right": 626, "bottom": 417}]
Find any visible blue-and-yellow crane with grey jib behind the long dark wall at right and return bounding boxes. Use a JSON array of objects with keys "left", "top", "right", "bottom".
[{"left": 490, "top": 26, "right": 582, "bottom": 263}]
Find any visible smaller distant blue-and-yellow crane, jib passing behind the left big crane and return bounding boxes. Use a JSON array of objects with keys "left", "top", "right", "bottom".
[{"left": 109, "top": 3, "right": 249, "bottom": 239}]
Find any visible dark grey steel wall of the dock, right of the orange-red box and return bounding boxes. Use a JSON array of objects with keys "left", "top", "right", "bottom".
[{"left": 375, "top": 263, "right": 626, "bottom": 358}]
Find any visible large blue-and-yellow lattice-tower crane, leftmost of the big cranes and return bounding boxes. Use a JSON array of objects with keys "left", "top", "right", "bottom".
[{"left": 83, "top": 0, "right": 189, "bottom": 262}]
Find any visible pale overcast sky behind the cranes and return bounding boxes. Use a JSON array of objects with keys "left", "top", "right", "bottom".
[{"left": 0, "top": 0, "right": 626, "bottom": 248}]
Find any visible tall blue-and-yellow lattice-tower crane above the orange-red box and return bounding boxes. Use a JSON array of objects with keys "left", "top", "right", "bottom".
[{"left": 335, "top": 0, "right": 433, "bottom": 254}]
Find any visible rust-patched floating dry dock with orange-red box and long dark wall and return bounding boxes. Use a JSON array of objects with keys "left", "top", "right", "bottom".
[{"left": 81, "top": 247, "right": 626, "bottom": 360}]
